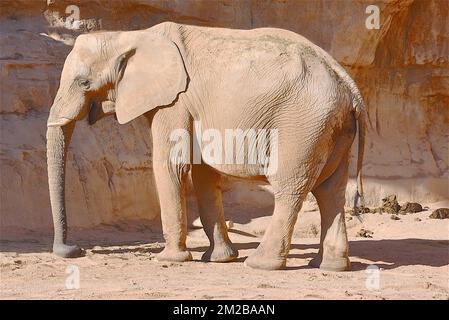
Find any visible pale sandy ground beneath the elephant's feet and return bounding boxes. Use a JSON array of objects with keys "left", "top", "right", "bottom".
[{"left": 0, "top": 203, "right": 449, "bottom": 299}]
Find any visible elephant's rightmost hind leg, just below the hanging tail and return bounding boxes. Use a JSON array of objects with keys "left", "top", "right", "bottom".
[{"left": 309, "top": 154, "right": 351, "bottom": 271}]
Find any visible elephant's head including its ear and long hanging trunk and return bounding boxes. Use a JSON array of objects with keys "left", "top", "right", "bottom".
[{"left": 47, "top": 29, "right": 188, "bottom": 257}]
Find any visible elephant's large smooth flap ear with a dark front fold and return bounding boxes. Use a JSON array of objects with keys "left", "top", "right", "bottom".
[{"left": 115, "top": 32, "right": 188, "bottom": 124}]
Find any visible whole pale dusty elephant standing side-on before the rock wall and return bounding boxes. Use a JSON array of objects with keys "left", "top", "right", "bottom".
[{"left": 47, "top": 22, "right": 366, "bottom": 271}]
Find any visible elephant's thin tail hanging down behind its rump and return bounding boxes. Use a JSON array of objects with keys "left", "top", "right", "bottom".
[{"left": 354, "top": 95, "right": 366, "bottom": 213}]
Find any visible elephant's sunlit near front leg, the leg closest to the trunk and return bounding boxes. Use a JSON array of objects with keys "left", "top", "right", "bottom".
[{"left": 154, "top": 161, "right": 192, "bottom": 262}]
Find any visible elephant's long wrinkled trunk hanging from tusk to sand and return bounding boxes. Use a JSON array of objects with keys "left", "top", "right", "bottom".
[{"left": 47, "top": 122, "right": 83, "bottom": 258}]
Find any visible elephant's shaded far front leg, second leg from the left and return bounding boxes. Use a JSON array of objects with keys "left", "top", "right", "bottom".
[{"left": 192, "top": 165, "right": 238, "bottom": 262}]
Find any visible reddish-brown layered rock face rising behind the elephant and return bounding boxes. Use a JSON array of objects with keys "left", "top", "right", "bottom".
[{"left": 0, "top": 0, "right": 449, "bottom": 229}]
